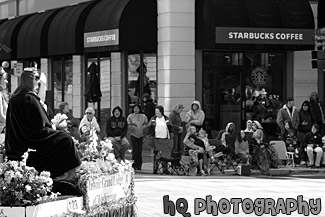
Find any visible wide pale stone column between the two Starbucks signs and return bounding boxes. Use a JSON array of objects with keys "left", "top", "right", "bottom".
[{"left": 157, "top": 0, "right": 195, "bottom": 116}]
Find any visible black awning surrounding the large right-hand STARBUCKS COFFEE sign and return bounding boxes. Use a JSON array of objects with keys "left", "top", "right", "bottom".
[{"left": 195, "top": 0, "right": 315, "bottom": 50}]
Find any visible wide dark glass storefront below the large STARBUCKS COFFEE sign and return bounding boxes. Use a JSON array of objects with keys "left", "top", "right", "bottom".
[{"left": 203, "top": 52, "right": 285, "bottom": 138}]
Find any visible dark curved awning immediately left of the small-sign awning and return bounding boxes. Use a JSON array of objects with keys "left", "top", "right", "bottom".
[{"left": 48, "top": 1, "right": 96, "bottom": 56}]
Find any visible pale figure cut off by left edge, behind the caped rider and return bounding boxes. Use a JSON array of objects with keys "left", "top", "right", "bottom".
[{"left": 0, "top": 68, "right": 9, "bottom": 133}]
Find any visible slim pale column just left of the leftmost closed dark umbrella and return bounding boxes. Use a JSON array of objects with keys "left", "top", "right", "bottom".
[{"left": 70, "top": 55, "right": 84, "bottom": 117}]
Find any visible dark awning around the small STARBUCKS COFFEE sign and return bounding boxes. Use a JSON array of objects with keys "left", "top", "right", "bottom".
[{"left": 84, "top": 0, "right": 157, "bottom": 52}]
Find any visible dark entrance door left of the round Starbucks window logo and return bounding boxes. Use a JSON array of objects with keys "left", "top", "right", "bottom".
[{"left": 203, "top": 53, "right": 245, "bottom": 134}]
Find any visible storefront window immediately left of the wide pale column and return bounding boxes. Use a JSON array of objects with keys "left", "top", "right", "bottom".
[{"left": 128, "top": 53, "right": 157, "bottom": 113}]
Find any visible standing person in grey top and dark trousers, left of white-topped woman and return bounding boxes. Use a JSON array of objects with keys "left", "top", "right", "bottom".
[{"left": 127, "top": 104, "right": 148, "bottom": 170}]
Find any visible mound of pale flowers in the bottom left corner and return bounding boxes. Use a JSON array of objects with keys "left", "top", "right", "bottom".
[{"left": 0, "top": 149, "right": 59, "bottom": 206}]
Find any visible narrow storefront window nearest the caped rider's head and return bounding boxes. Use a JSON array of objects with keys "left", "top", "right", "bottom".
[{"left": 52, "top": 56, "right": 73, "bottom": 111}]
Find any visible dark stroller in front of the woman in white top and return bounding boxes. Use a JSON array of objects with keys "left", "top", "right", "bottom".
[{"left": 153, "top": 139, "right": 182, "bottom": 175}]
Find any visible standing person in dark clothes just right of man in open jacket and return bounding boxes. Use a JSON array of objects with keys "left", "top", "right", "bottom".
[{"left": 298, "top": 100, "right": 315, "bottom": 165}]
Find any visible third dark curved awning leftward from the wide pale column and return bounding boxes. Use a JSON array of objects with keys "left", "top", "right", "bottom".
[{"left": 17, "top": 10, "right": 58, "bottom": 59}]
